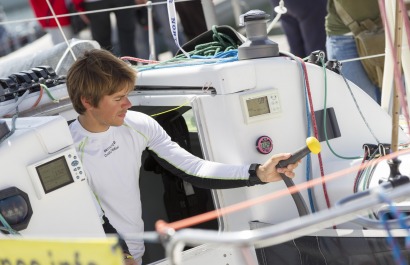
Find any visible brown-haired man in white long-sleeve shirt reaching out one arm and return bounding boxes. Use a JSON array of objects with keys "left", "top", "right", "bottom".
[{"left": 67, "top": 49, "right": 297, "bottom": 264}]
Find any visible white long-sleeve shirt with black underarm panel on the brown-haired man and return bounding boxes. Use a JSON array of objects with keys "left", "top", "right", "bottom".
[{"left": 70, "top": 111, "right": 251, "bottom": 260}]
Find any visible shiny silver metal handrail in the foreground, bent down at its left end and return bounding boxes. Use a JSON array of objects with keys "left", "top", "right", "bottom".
[{"left": 162, "top": 184, "right": 410, "bottom": 265}]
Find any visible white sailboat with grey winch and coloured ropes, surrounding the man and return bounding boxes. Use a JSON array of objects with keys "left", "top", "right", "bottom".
[{"left": 0, "top": 0, "right": 410, "bottom": 264}]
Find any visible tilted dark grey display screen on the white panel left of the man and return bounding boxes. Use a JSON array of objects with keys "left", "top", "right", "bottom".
[{"left": 36, "top": 156, "right": 74, "bottom": 193}]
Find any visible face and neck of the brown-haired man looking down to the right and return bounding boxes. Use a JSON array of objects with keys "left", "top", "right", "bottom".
[{"left": 86, "top": 88, "right": 132, "bottom": 132}]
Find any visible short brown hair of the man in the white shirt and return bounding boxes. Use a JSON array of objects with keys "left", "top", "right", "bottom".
[{"left": 67, "top": 49, "right": 137, "bottom": 114}]
